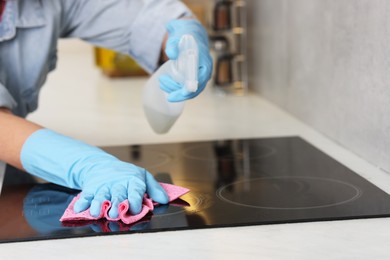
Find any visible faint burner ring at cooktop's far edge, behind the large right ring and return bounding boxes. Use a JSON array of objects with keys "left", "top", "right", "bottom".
[{"left": 183, "top": 144, "right": 277, "bottom": 161}]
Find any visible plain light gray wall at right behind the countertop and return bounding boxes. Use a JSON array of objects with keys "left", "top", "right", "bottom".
[{"left": 247, "top": 0, "right": 390, "bottom": 172}]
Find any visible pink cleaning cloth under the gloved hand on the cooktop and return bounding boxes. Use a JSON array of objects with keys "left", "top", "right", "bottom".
[{"left": 60, "top": 183, "right": 189, "bottom": 224}]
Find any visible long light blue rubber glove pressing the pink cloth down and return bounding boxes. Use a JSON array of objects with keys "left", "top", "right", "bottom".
[{"left": 21, "top": 129, "right": 168, "bottom": 218}]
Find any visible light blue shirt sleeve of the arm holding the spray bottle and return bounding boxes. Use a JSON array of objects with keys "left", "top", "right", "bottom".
[{"left": 61, "top": 0, "right": 191, "bottom": 73}]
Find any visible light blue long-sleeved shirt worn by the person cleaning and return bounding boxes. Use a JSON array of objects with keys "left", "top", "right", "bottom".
[{"left": 0, "top": 0, "right": 190, "bottom": 117}]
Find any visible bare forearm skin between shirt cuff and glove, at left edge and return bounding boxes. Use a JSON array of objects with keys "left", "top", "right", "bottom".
[{"left": 0, "top": 108, "right": 42, "bottom": 169}]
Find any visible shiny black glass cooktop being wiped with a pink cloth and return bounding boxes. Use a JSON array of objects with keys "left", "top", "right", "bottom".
[{"left": 0, "top": 137, "right": 390, "bottom": 242}]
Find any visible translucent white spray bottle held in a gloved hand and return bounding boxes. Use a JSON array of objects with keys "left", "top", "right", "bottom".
[{"left": 142, "top": 34, "right": 199, "bottom": 134}]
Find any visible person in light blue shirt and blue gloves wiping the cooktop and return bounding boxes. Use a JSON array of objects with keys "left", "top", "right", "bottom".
[{"left": 0, "top": 0, "right": 212, "bottom": 218}]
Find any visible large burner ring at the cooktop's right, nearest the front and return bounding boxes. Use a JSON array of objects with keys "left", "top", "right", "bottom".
[{"left": 216, "top": 176, "right": 363, "bottom": 210}]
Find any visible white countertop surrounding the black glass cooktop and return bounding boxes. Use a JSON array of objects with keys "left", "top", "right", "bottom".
[{"left": 0, "top": 39, "right": 390, "bottom": 259}]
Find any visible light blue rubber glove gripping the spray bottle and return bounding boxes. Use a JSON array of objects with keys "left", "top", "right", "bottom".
[{"left": 159, "top": 19, "right": 213, "bottom": 102}]
